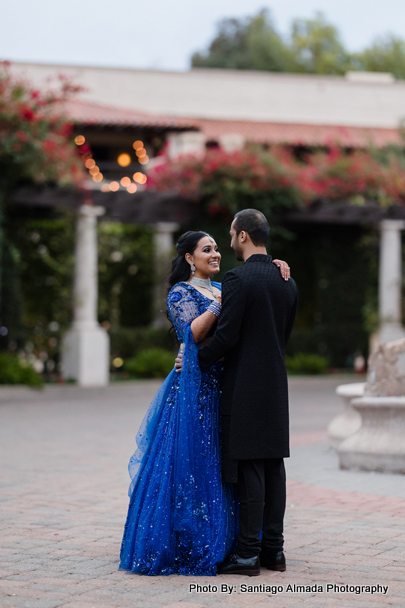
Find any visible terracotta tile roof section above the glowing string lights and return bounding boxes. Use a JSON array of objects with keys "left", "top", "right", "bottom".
[{"left": 65, "top": 100, "right": 195, "bottom": 129}]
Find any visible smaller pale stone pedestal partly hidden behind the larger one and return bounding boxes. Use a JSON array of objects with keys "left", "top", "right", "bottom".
[{"left": 328, "top": 382, "right": 366, "bottom": 449}]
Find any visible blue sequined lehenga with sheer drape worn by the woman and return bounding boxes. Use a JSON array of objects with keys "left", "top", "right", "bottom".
[{"left": 120, "top": 282, "right": 237, "bottom": 575}]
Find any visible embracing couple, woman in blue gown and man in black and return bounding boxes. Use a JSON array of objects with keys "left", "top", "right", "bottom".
[{"left": 120, "top": 209, "right": 297, "bottom": 576}]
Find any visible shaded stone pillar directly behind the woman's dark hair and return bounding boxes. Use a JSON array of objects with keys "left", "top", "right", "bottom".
[{"left": 153, "top": 222, "right": 180, "bottom": 327}]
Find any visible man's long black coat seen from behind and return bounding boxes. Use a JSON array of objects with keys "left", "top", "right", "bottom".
[{"left": 199, "top": 254, "right": 298, "bottom": 482}]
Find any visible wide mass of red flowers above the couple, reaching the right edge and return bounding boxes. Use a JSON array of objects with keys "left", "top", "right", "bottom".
[{"left": 148, "top": 147, "right": 405, "bottom": 213}]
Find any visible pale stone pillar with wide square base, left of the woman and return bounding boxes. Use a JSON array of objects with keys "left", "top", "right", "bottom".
[{"left": 62, "top": 205, "right": 109, "bottom": 386}]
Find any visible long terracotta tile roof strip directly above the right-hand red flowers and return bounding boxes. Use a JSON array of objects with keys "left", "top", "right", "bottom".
[{"left": 194, "top": 119, "right": 403, "bottom": 147}]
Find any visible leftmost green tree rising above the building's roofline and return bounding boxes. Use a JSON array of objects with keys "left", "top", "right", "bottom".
[{"left": 191, "top": 10, "right": 295, "bottom": 72}]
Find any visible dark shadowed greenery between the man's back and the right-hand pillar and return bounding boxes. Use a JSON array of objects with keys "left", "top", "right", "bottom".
[{"left": 280, "top": 225, "right": 378, "bottom": 367}]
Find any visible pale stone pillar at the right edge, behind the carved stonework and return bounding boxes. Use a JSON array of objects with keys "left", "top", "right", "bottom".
[{"left": 378, "top": 220, "right": 405, "bottom": 342}]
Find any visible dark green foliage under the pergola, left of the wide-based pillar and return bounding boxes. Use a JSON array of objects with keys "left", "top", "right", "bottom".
[{"left": 8, "top": 214, "right": 75, "bottom": 361}]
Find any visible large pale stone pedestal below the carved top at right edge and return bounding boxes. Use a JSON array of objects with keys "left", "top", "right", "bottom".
[{"left": 338, "top": 396, "right": 405, "bottom": 474}]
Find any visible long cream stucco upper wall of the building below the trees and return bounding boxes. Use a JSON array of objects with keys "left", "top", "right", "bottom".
[{"left": 13, "top": 63, "right": 405, "bottom": 128}]
